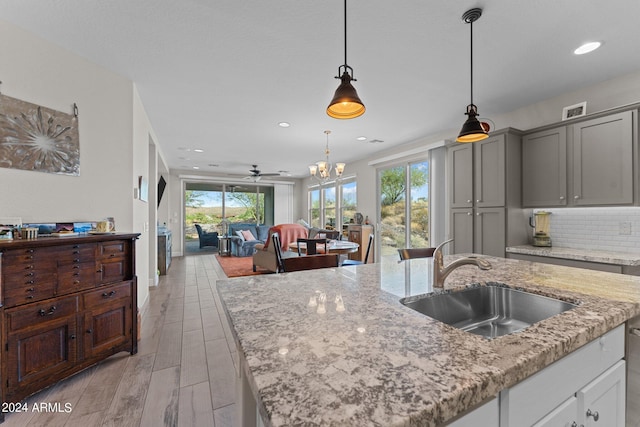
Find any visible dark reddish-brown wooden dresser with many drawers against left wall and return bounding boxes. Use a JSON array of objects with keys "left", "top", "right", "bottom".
[{"left": 0, "top": 234, "right": 139, "bottom": 412}]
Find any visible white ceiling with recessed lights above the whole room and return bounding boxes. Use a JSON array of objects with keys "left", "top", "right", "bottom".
[{"left": 0, "top": 0, "right": 640, "bottom": 176}]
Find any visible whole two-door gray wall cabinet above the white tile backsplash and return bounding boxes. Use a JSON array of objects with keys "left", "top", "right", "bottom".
[{"left": 522, "top": 107, "right": 637, "bottom": 208}]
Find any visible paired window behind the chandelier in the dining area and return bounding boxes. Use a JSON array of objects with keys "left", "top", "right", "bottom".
[{"left": 308, "top": 178, "right": 357, "bottom": 236}]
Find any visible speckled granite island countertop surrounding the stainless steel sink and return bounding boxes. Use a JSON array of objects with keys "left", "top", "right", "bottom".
[{"left": 217, "top": 257, "right": 640, "bottom": 426}]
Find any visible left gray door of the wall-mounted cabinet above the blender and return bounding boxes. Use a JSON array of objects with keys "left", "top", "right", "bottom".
[{"left": 522, "top": 126, "right": 567, "bottom": 208}]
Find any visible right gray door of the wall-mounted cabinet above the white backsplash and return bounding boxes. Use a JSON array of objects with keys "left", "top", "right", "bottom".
[{"left": 572, "top": 111, "right": 633, "bottom": 206}]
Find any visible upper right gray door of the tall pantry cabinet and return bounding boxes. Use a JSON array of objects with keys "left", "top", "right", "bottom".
[{"left": 474, "top": 135, "right": 505, "bottom": 208}]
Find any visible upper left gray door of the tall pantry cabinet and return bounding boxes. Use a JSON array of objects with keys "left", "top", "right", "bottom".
[{"left": 447, "top": 144, "right": 473, "bottom": 208}]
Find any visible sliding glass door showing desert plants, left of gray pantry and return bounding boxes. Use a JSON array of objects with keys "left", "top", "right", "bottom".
[{"left": 378, "top": 160, "right": 430, "bottom": 257}]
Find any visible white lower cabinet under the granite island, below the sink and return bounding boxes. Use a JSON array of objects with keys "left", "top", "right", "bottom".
[{"left": 500, "top": 325, "right": 626, "bottom": 427}]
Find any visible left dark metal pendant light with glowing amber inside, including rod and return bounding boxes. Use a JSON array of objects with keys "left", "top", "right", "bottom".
[{"left": 327, "top": 0, "right": 366, "bottom": 119}]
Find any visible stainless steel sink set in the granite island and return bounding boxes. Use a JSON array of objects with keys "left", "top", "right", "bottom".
[{"left": 400, "top": 285, "right": 576, "bottom": 338}]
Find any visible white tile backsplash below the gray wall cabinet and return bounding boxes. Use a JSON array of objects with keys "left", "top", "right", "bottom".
[{"left": 536, "top": 207, "right": 640, "bottom": 252}]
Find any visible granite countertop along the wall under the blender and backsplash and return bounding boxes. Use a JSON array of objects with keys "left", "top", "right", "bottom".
[{"left": 506, "top": 245, "right": 640, "bottom": 267}]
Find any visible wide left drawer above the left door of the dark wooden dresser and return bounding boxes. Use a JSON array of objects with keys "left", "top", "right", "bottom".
[{"left": 5, "top": 296, "right": 78, "bottom": 332}]
